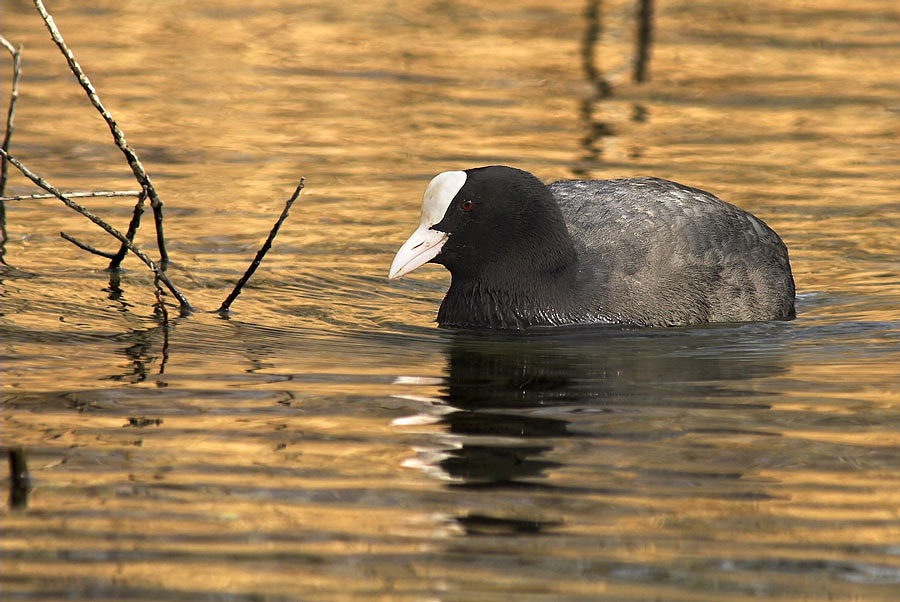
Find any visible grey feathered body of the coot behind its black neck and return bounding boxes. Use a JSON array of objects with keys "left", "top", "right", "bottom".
[{"left": 548, "top": 178, "right": 795, "bottom": 326}]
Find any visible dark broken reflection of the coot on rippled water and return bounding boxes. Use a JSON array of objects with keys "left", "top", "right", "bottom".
[{"left": 398, "top": 327, "right": 783, "bottom": 533}]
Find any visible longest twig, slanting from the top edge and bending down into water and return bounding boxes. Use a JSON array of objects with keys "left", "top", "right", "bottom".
[{"left": 34, "top": 0, "right": 169, "bottom": 266}]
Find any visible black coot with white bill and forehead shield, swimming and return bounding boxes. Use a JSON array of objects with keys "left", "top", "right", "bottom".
[{"left": 389, "top": 165, "right": 795, "bottom": 330}]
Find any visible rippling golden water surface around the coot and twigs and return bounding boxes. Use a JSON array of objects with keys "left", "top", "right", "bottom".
[{"left": 0, "top": 0, "right": 900, "bottom": 602}]
